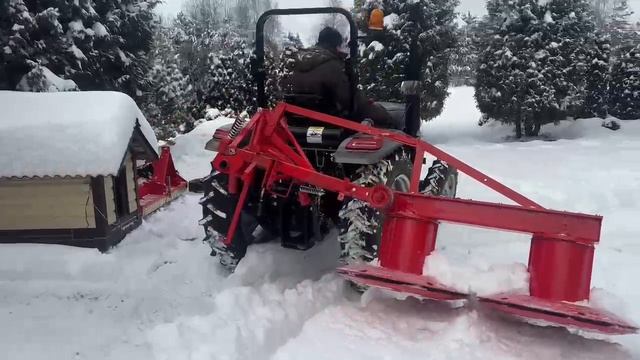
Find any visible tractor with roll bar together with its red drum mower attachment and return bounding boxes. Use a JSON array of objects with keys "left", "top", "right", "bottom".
[{"left": 192, "top": 8, "right": 637, "bottom": 334}]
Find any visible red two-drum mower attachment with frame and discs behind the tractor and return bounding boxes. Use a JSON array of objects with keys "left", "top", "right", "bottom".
[{"left": 212, "top": 103, "right": 637, "bottom": 334}]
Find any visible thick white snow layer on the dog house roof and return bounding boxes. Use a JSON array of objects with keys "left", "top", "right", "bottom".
[{"left": 0, "top": 91, "right": 158, "bottom": 178}]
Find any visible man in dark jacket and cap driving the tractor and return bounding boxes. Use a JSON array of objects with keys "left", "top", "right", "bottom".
[{"left": 286, "top": 27, "right": 391, "bottom": 127}]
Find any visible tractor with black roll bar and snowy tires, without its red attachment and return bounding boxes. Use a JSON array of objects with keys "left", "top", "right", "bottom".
[{"left": 202, "top": 8, "right": 457, "bottom": 270}]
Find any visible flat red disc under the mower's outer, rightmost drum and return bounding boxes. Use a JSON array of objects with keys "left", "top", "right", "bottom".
[{"left": 479, "top": 294, "right": 638, "bottom": 335}]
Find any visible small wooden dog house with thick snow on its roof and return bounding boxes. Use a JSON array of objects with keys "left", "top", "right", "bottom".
[{"left": 0, "top": 91, "right": 158, "bottom": 250}]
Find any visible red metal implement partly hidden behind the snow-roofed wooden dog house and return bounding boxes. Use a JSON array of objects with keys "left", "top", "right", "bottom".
[{"left": 138, "top": 146, "right": 187, "bottom": 216}]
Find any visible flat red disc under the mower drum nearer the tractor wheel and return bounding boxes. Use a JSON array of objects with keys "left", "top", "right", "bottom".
[{"left": 337, "top": 265, "right": 467, "bottom": 301}]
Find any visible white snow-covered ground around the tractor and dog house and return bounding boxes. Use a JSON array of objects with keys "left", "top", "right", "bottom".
[{"left": 0, "top": 88, "right": 640, "bottom": 360}]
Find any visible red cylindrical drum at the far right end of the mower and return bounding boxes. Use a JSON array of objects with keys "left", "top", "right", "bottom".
[{"left": 529, "top": 235, "right": 595, "bottom": 302}]
